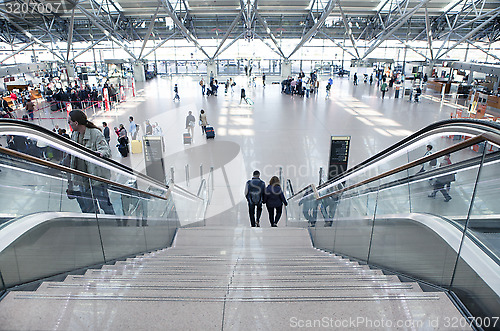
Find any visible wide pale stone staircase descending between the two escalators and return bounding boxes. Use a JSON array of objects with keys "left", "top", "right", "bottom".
[{"left": 0, "top": 227, "right": 466, "bottom": 330}]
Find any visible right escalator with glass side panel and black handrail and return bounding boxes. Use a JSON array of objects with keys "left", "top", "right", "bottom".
[{"left": 287, "top": 120, "right": 500, "bottom": 329}]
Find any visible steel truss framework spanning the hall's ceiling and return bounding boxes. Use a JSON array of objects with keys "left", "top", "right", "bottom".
[{"left": 0, "top": 0, "right": 500, "bottom": 62}]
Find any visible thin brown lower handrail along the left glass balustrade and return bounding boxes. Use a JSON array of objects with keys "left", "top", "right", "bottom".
[{"left": 0, "top": 146, "right": 172, "bottom": 200}]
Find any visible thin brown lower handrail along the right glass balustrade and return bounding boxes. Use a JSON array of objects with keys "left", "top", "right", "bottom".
[{"left": 290, "top": 132, "right": 500, "bottom": 200}]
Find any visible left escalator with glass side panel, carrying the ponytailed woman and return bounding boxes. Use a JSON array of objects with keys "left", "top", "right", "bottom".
[{"left": 0, "top": 120, "right": 208, "bottom": 292}]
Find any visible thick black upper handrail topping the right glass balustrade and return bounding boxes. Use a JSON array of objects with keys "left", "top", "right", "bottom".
[{"left": 316, "top": 118, "right": 500, "bottom": 194}]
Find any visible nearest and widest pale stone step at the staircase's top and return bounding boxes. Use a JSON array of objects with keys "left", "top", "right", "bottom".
[{"left": 1, "top": 293, "right": 466, "bottom": 331}]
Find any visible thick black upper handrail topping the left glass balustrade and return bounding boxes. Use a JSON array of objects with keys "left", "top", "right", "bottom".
[{"left": 0, "top": 118, "right": 168, "bottom": 190}]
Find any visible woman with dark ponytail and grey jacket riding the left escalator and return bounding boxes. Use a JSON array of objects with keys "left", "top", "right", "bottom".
[{"left": 67, "top": 110, "right": 115, "bottom": 215}]
